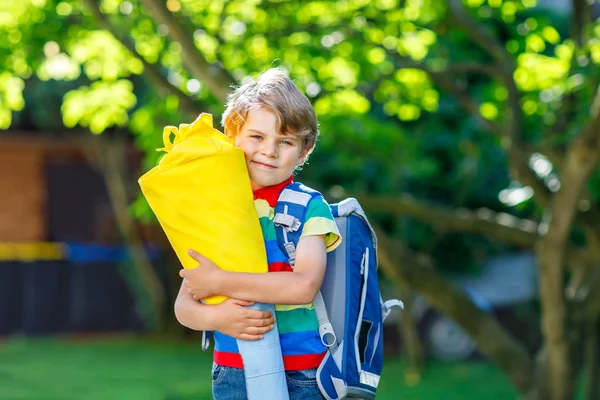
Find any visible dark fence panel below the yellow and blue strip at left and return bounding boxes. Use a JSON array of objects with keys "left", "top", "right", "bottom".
[{"left": 0, "top": 261, "right": 142, "bottom": 335}]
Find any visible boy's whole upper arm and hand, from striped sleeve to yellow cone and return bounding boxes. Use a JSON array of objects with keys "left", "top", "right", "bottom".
[{"left": 180, "top": 235, "right": 327, "bottom": 304}]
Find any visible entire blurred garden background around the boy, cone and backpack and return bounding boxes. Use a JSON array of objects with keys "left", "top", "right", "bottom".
[{"left": 0, "top": 0, "right": 600, "bottom": 400}]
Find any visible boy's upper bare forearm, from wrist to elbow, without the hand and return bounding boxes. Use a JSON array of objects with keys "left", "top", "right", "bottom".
[{"left": 217, "top": 271, "right": 321, "bottom": 304}]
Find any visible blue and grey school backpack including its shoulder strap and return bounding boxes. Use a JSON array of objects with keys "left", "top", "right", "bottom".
[{"left": 273, "top": 182, "right": 403, "bottom": 400}]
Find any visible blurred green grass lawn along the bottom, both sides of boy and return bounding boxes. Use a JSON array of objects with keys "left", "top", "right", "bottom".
[{"left": 0, "top": 337, "right": 516, "bottom": 400}]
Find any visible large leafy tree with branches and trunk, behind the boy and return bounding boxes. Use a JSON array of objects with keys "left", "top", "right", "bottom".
[{"left": 0, "top": 0, "right": 600, "bottom": 399}]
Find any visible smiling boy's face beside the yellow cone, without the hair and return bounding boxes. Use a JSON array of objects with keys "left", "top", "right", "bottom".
[{"left": 236, "top": 107, "right": 306, "bottom": 190}]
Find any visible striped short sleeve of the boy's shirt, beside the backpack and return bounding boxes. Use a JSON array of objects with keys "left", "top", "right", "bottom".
[{"left": 300, "top": 196, "right": 342, "bottom": 252}]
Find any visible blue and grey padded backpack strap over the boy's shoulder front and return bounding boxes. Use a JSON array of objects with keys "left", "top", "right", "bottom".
[{"left": 273, "top": 182, "right": 321, "bottom": 268}]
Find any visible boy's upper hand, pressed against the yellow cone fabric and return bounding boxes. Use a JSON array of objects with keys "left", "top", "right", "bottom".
[{"left": 179, "top": 249, "right": 221, "bottom": 300}]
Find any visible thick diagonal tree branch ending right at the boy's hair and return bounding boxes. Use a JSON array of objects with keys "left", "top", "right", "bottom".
[{"left": 141, "top": 0, "right": 235, "bottom": 104}]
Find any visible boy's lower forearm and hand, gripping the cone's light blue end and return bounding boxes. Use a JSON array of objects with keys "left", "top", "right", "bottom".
[{"left": 174, "top": 281, "right": 275, "bottom": 340}]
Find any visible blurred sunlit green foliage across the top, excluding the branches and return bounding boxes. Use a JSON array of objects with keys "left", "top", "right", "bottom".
[{"left": 0, "top": 0, "right": 600, "bottom": 268}]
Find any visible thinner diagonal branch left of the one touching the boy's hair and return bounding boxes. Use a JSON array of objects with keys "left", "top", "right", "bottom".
[{"left": 84, "top": 0, "right": 203, "bottom": 117}]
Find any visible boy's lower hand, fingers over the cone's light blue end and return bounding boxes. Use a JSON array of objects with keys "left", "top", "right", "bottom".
[{"left": 211, "top": 299, "right": 275, "bottom": 340}]
